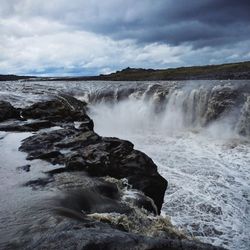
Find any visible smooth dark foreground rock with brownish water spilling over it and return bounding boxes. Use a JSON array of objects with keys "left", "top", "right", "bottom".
[{"left": 17, "top": 172, "right": 225, "bottom": 250}]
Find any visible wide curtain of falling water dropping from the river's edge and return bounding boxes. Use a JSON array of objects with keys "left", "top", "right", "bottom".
[{"left": 88, "top": 81, "right": 250, "bottom": 135}]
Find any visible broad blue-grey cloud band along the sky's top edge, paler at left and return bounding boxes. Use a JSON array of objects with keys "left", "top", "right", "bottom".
[{"left": 2, "top": 0, "right": 250, "bottom": 47}]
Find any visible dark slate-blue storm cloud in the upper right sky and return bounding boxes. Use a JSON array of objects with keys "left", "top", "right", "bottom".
[{"left": 76, "top": 0, "right": 250, "bottom": 47}]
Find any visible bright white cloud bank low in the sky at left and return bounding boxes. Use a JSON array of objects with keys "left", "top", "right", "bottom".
[{"left": 0, "top": 18, "right": 193, "bottom": 74}]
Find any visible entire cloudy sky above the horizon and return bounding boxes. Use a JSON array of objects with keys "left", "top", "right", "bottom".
[{"left": 0, "top": 0, "right": 250, "bottom": 76}]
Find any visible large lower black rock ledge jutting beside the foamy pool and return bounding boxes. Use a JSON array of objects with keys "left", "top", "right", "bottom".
[{"left": 20, "top": 129, "right": 167, "bottom": 213}]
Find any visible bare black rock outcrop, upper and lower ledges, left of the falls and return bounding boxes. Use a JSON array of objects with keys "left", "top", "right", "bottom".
[{"left": 15, "top": 96, "right": 167, "bottom": 213}]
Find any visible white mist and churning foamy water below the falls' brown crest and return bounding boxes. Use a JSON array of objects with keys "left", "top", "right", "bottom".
[{"left": 90, "top": 98, "right": 250, "bottom": 250}]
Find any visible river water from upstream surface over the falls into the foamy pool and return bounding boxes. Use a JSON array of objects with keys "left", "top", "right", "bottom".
[{"left": 0, "top": 81, "right": 250, "bottom": 250}]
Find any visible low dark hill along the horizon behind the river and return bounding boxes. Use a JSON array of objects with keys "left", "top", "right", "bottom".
[{"left": 0, "top": 61, "right": 250, "bottom": 81}]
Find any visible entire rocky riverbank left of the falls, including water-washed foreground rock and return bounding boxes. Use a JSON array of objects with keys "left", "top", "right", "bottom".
[{"left": 0, "top": 95, "right": 225, "bottom": 249}]
